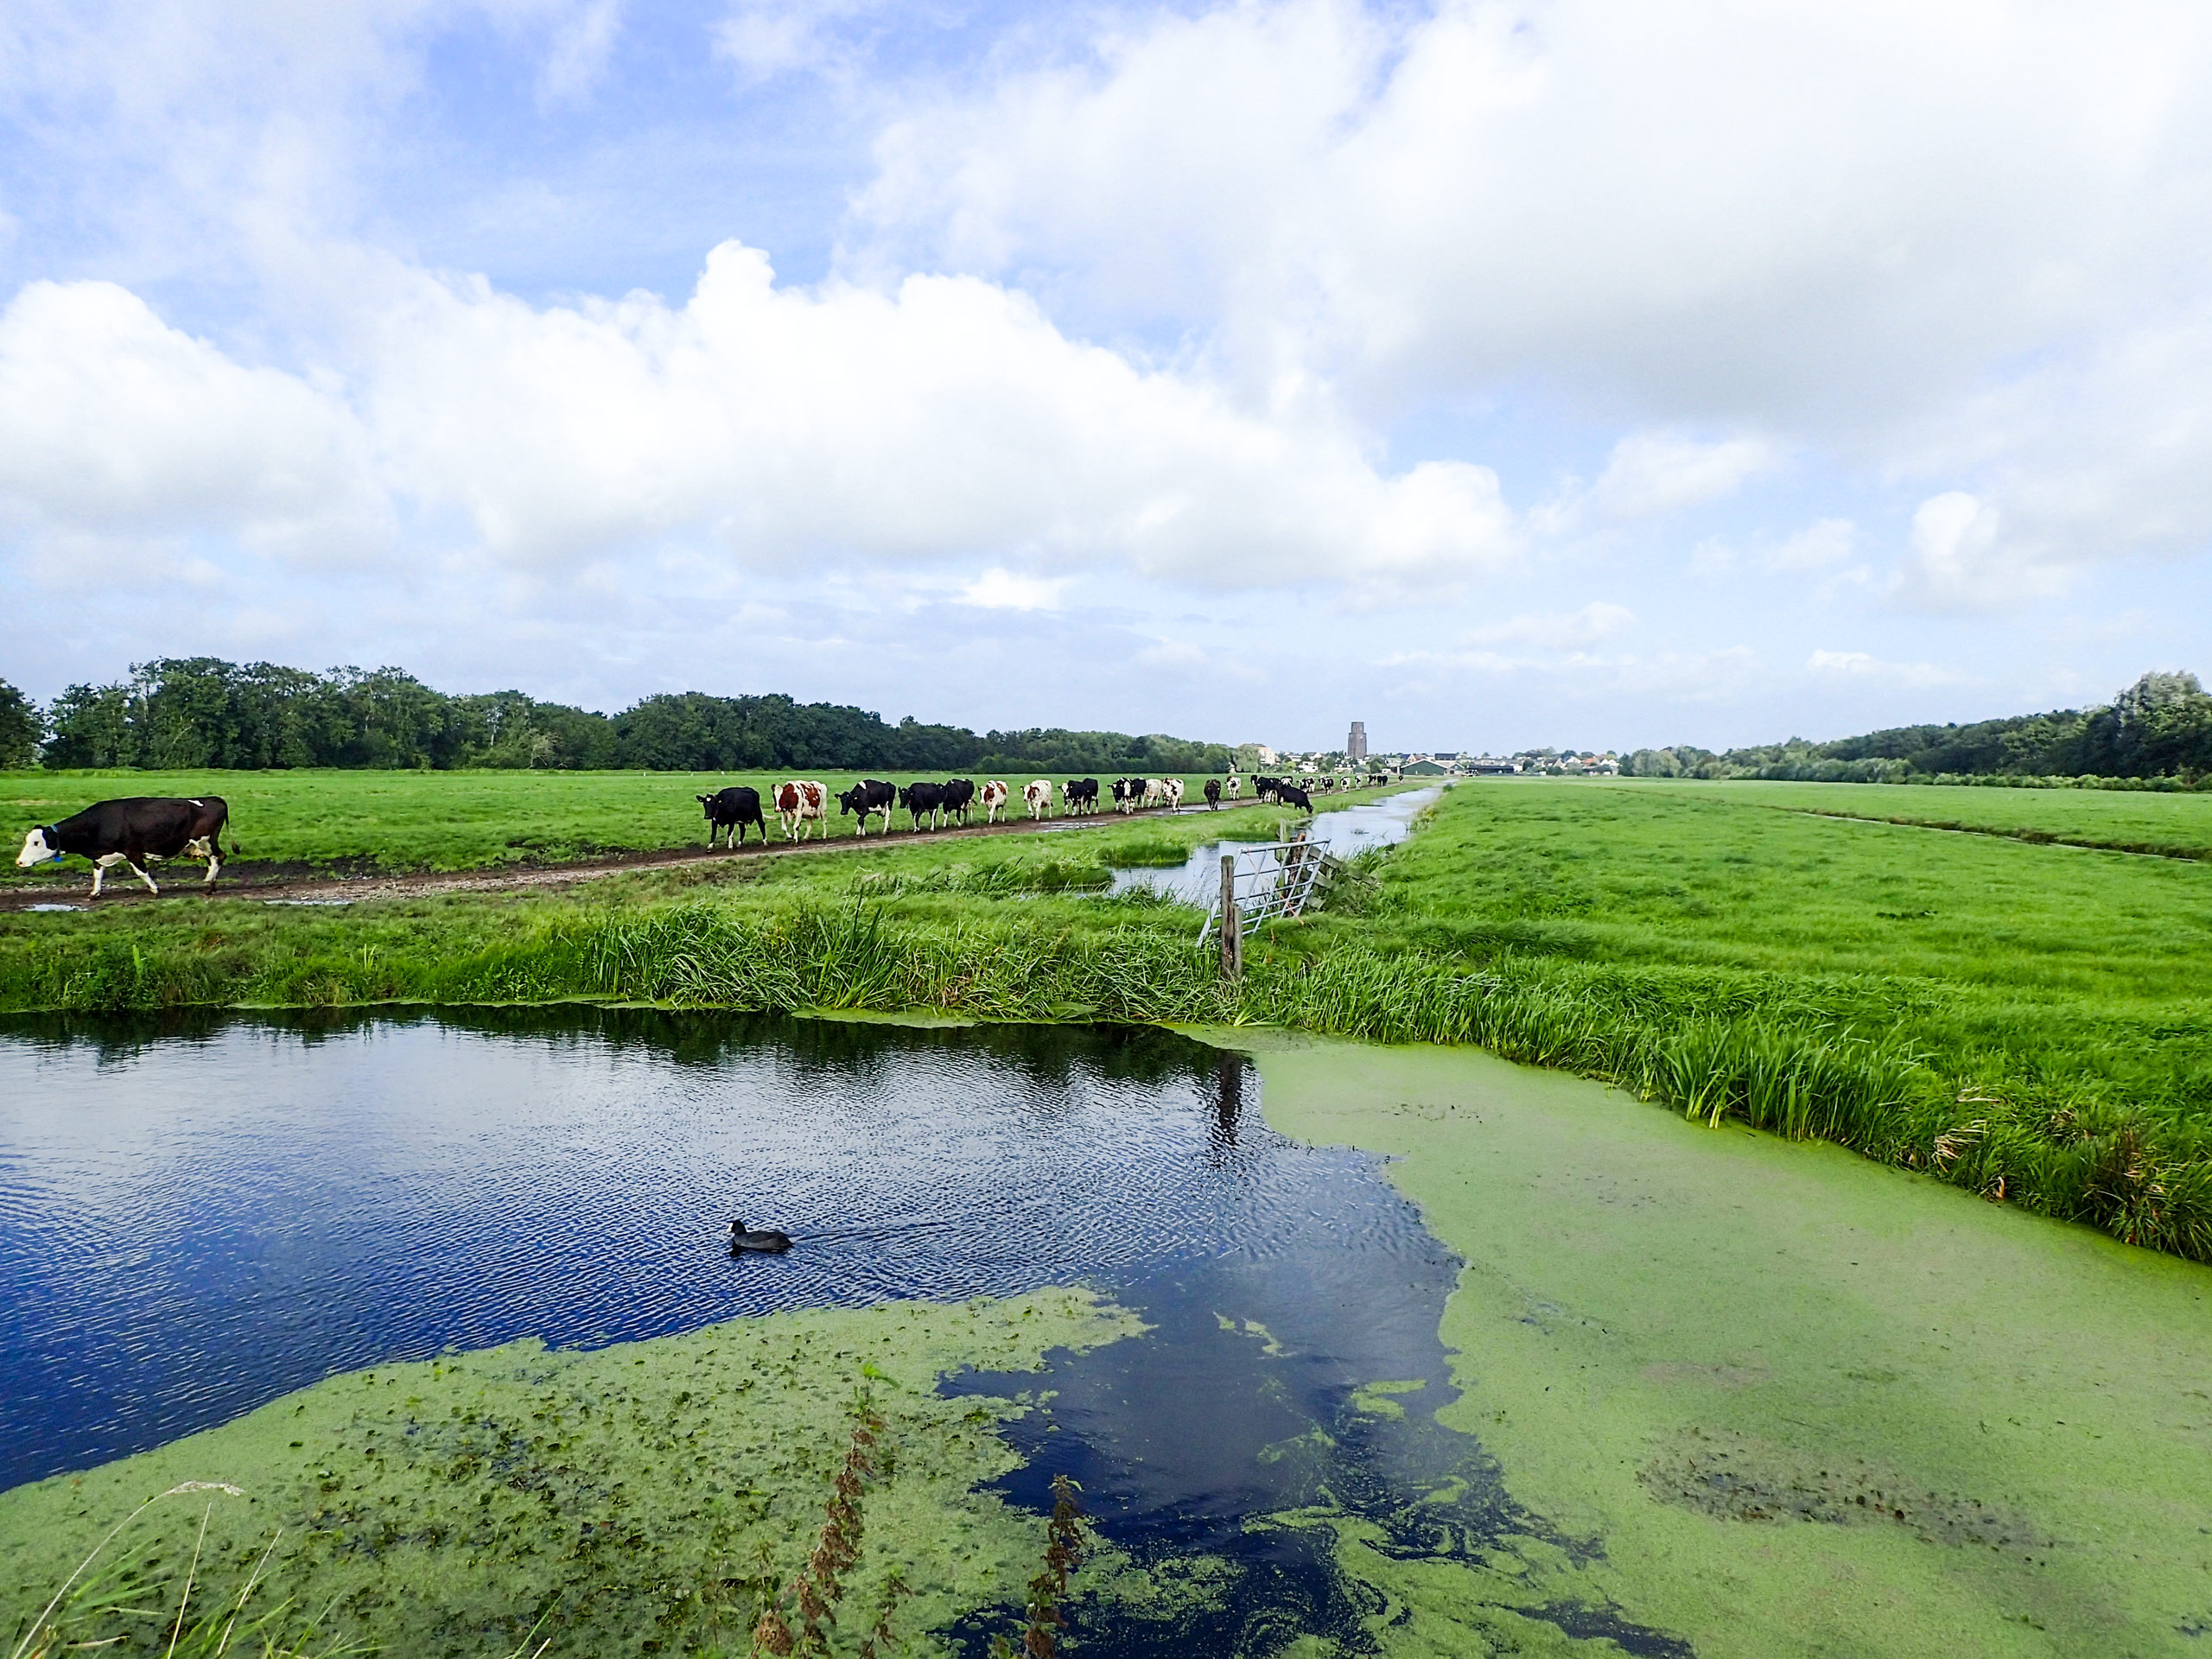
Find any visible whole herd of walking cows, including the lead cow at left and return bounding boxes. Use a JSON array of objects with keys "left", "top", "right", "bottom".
[{"left": 16, "top": 772, "right": 1314, "bottom": 898}]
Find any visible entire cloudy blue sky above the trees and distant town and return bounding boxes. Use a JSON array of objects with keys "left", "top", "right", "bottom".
[{"left": 0, "top": 0, "right": 2212, "bottom": 750}]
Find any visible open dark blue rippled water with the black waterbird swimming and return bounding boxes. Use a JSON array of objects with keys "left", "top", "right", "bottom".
[{"left": 0, "top": 1011, "right": 1675, "bottom": 1655}]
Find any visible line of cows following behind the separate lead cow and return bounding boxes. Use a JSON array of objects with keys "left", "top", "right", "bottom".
[{"left": 695, "top": 772, "right": 1314, "bottom": 847}]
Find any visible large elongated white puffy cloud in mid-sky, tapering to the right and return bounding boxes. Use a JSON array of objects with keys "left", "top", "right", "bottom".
[{"left": 370, "top": 244, "right": 1513, "bottom": 586}]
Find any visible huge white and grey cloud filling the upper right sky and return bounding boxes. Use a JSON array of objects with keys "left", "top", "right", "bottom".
[{"left": 852, "top": 0, "right": 2212, "bottom": 579}]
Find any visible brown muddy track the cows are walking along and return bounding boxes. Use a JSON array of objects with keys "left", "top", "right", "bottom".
[{"left": 0, "top": 801, "right": 1281, "bottom": 912}]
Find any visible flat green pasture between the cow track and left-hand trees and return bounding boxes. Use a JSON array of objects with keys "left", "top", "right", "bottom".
[{"left": 0, "top": 772, "right": 1282, "bottom": 876}]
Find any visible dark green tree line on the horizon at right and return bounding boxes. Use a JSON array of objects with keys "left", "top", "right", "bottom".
[{"left": 1621, "top": 672, "right": 2212, "bottom": 787}]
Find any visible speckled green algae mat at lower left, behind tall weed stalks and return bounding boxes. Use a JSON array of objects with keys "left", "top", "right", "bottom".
[{"left": 0, "top": 1289, "right": 1144, "bottom": 1659}]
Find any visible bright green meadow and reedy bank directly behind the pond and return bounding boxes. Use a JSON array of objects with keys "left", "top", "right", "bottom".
[{"left": 0, "top": 774, "right": 2212, "bottom": 1261}]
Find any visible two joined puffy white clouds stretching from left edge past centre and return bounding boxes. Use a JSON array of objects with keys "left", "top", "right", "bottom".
[{"left": 0, "top": 244, "right": 1517, "bottom": 601}]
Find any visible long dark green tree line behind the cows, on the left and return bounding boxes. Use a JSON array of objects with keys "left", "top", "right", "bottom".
[{"left": 0, "top": 657, "right": 1230, "bottom": 772}]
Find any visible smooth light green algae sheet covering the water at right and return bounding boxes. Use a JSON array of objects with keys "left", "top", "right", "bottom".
[{"left": 1217, "top": 1031, "right": 2212, "bottom": 1659}]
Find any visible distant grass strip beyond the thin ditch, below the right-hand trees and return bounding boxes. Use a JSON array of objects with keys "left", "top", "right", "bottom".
[{"left": 1606, "top": 779, "right": 2212, "bottom": 858}]
